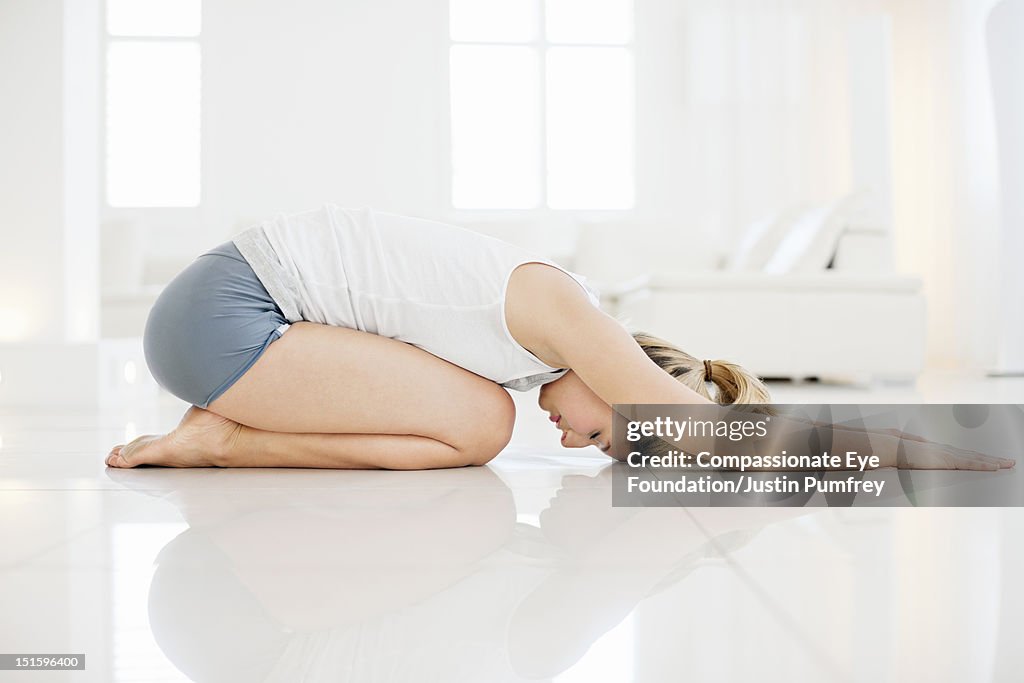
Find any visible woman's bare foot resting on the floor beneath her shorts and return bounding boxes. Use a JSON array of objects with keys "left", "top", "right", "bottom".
[{"left": 106, "top": 405, "right": 242, "bottom": 468}]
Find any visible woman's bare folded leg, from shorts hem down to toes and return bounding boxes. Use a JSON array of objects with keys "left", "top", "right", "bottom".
[{"left": 108, "top": 323, "right": 515, "bottom": 469}]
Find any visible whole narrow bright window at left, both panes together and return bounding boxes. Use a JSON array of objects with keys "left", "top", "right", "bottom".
[{"left": 105, "top": 0, "right": 201, "bottom": 207}]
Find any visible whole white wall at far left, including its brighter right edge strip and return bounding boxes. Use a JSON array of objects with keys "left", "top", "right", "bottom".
[{"left": 0, "top": 0, "right": 99, "bottom": 344}]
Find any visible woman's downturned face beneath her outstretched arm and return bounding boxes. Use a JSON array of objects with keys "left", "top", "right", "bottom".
[{"left": 538, "top": 370, "right": 611, "bottom": 453}]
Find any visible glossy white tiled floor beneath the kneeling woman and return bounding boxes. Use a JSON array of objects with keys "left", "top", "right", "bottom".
[{"left": 0, "top": 375, "right": 1024, "bottom": 683}]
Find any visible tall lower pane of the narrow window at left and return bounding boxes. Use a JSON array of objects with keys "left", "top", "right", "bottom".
[{"left": 106, "top": 41, "right": 200, "bottom": 207}]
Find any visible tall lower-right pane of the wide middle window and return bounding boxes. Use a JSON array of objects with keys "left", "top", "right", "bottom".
[{"left": 547, "top": 47, "right": 634, "bottom": 209}]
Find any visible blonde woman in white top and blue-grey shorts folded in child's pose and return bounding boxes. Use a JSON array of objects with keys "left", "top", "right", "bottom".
[{"left": 106, "top": 204, "right": 1012, "bottom": 469}]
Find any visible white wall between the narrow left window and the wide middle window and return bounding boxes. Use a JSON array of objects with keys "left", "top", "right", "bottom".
[{"left": 104, "top": 0, "right": 447, "bottom": 268}]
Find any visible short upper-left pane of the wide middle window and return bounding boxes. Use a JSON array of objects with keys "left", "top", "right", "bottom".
[{"left": 449, "top": 0, "right": 540, "bottom": 43}]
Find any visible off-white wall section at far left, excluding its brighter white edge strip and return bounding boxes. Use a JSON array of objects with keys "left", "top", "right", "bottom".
[{"left": 0, "top": 0, "right": 65, "bottom": 343}]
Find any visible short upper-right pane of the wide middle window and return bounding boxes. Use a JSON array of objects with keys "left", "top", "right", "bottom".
[{"left": 545, "top": 0, "right": 633, "bottom": 44}]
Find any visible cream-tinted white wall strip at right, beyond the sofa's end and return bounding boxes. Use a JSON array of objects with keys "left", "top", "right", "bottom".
[{"left": 888, "top": 0, "right": 1005, "bottom": 370}]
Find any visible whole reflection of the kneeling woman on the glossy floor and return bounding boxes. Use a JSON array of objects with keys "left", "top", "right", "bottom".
[{"left": 118, "top": 468, "right": 808, "bottom": 683}]
